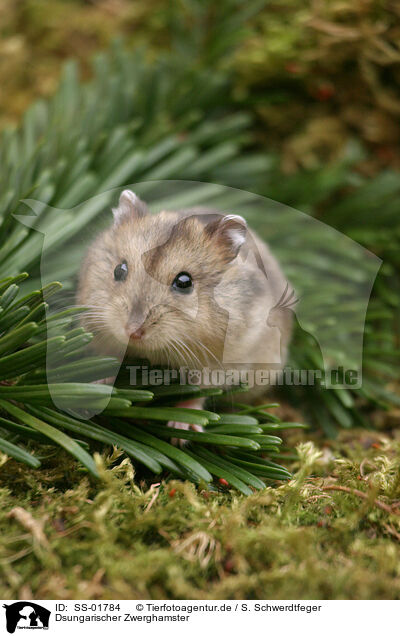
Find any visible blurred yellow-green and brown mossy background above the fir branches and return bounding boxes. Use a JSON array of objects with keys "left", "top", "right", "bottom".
[{"left": 0, "top": 0, "right": 400, "bottom": 174}]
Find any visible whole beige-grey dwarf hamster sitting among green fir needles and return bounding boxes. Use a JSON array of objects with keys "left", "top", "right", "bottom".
[{"left": 77, "top": 190, "right": 294, "bottom": 428}]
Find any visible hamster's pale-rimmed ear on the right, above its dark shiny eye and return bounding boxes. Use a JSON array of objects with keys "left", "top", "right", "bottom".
[{"left": 205, "top": 214, "right": 247, "bottom": 263}]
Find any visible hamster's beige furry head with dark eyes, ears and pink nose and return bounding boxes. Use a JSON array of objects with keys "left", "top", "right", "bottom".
[{"left": 78, "top": 190, "right": 246, "bottom": 368}]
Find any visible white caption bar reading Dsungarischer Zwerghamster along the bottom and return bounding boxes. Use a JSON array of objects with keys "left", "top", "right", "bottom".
[{"left": 0, "top": 600, "right": 400, "bottom": 636}]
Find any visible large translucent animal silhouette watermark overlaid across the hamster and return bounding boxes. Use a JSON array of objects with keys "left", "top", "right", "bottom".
[{"left": 14, "top": 180, "right": 381, "bottom": 410}]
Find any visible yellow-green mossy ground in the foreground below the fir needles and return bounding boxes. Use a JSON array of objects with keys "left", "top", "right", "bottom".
[{"left": 0, "top": 430, "right": 400, "bottom": 599}]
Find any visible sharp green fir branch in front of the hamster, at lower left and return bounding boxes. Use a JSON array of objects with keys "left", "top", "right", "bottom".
[{"left": 0, "top": 276, "right": 300, "bottom": 494}]
